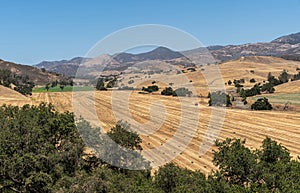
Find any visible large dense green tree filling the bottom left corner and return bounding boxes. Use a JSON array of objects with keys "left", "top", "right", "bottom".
[{"left": 0, "top": 103, "right": 83, "bottom": 192}]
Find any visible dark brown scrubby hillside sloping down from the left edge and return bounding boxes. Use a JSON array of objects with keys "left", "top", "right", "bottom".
[{"left": 0, "top": 59, "right": 63, "bottom": 85}]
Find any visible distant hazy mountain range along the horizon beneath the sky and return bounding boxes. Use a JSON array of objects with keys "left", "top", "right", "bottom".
[{"left": 35, "top": 32, "right": 300, "bottom": 76}]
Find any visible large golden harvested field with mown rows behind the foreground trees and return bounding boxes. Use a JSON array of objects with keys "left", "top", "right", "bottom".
[{"left": 30, "top": 91, "right": 300, "bottom": 173}]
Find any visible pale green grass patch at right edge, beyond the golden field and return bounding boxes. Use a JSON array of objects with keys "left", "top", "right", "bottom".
[{"left": 253, "top": 93, "right": 300, "bottom": 106}]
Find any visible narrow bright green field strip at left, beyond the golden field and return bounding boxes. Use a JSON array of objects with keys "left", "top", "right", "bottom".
[{"left": 32, "top": 86, "right": 95, "bottom": 93}]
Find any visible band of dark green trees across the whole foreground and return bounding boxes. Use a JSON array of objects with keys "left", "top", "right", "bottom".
[{"left": 0, "top": 104, "right": 300, "bottom": 193}]
